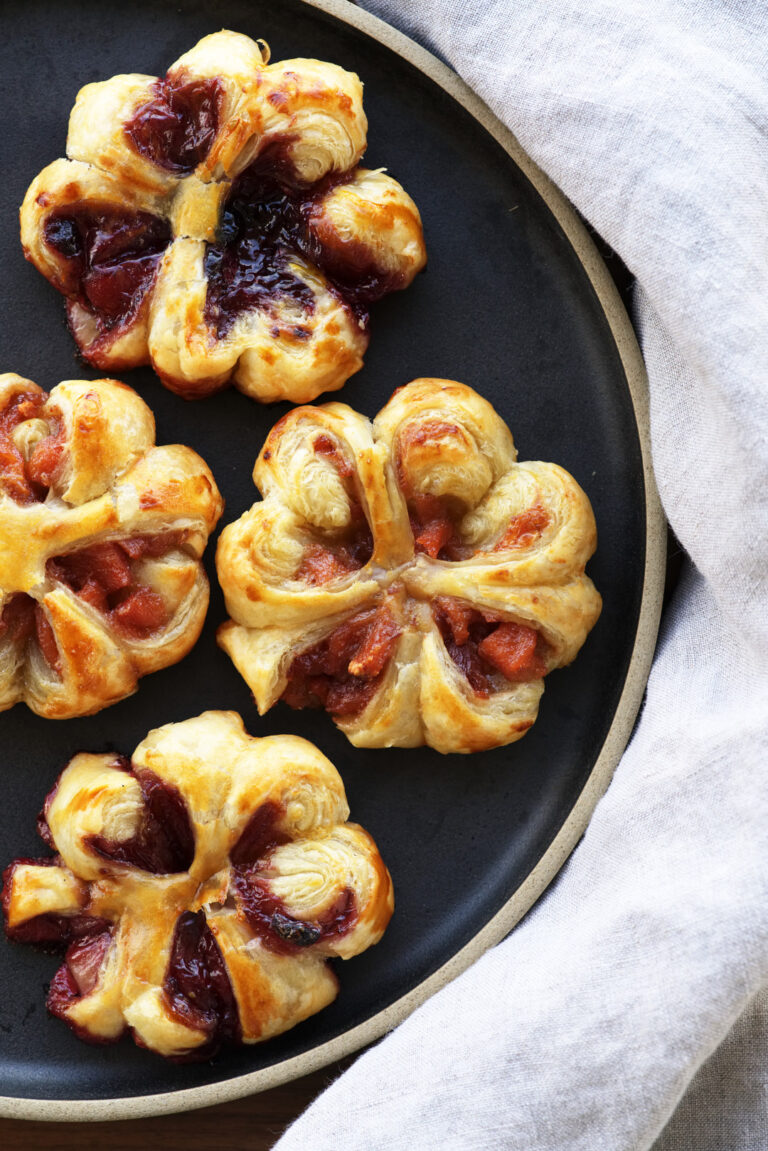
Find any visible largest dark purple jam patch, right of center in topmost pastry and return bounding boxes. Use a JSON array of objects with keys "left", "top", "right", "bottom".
[{"left": 205, "top": 138, "right": 402, "bottom": 340}]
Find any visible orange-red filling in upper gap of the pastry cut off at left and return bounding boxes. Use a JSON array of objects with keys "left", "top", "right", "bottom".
[{"left": 0, "top": 391, "right": 64, "bottom": 504}]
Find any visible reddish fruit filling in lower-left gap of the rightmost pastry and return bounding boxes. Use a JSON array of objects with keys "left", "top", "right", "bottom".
[{"left": 281, "top": 604, "right": 401, "bottom": 717}]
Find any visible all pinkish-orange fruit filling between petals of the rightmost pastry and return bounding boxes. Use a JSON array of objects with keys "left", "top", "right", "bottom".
[{"left": 272, "top": 419, "right": 552, "bottom": 718}]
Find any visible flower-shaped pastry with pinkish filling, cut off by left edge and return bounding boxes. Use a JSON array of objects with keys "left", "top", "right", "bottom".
[{"left": 0, "top": 373, "right": 223, "bottom": 719}]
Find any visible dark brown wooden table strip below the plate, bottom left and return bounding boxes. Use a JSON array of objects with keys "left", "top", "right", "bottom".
[{"left": 0, "top": 1055, "right": 355, "bottom": 1151}]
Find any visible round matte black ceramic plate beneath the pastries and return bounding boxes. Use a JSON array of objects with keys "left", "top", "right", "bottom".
[{"left": 0, "top": 0, "right": 661, "bottom": 1119}]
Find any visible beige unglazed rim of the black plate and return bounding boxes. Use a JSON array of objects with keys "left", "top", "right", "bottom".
[{"left": 0, "top": 0, "right": 667, "bottom": 1122}]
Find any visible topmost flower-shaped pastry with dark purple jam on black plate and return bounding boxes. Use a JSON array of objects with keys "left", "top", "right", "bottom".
[{"left": 21, "top": 31, "right": 426, "bottom": 403}]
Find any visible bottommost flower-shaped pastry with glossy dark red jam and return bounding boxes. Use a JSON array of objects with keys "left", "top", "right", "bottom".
[{"left": 2, "top": 711, "right": 394, "bottom": 1059}]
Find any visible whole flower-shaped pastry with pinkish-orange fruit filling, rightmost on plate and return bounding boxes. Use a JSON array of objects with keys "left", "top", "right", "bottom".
[{"left": 216, "top": 379, "right": 601, "bottom": 752}]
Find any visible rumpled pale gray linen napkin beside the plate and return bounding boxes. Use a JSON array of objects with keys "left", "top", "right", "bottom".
[{"left": 279, "top": 0, "right": 768, "bottom": 1151}]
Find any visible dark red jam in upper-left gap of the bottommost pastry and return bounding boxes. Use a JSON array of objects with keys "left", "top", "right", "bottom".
[{"left": 78, "top": 759, "right": 195, "bottom": 875}]
